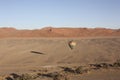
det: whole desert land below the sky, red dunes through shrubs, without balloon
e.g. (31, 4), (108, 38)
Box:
(0, 27), (120, 80)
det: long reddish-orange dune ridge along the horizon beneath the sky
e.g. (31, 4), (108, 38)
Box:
(0, 27), (120, 38)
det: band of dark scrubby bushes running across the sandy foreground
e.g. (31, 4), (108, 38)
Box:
(2, 60), (120, 80)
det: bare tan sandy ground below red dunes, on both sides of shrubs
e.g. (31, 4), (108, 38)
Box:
(0, 37), (120, 80)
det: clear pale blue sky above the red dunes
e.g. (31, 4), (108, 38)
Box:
(0, 0), (120, 29)
